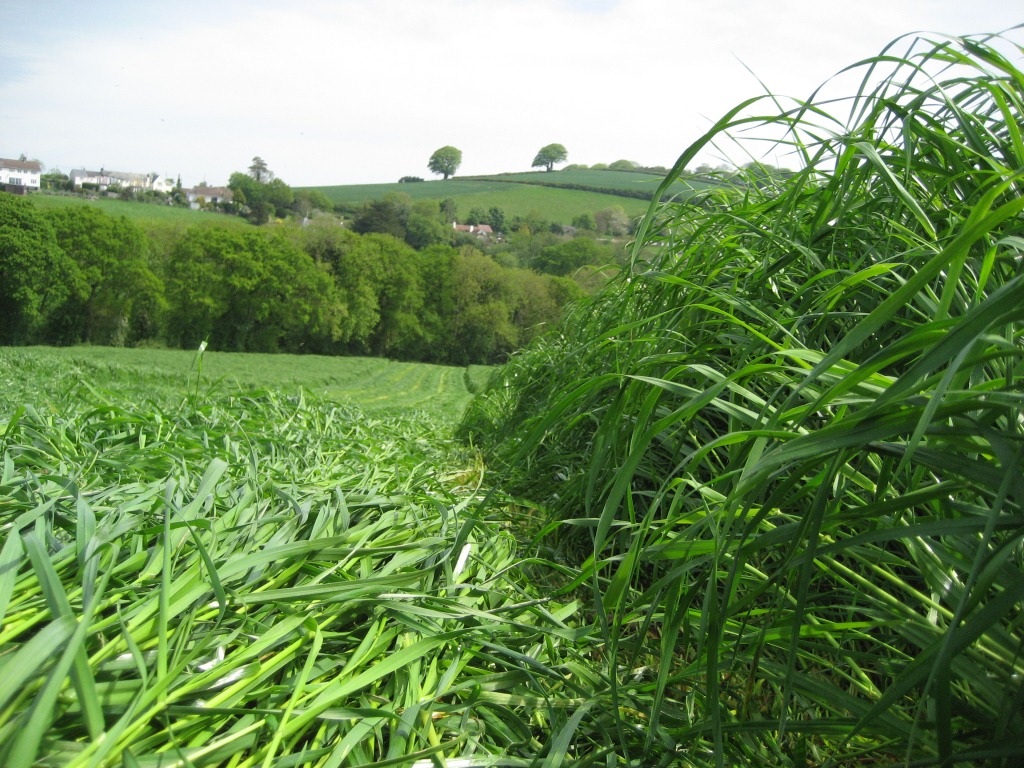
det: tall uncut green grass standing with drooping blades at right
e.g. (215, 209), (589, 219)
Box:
(465, 30), (1024, 766)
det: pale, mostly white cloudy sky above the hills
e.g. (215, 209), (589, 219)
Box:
(0, 0), (1024, 186)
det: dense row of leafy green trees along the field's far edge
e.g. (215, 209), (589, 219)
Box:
(0, 191), (585, 365)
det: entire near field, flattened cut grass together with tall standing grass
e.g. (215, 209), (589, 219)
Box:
(0, 27), (1024, 768)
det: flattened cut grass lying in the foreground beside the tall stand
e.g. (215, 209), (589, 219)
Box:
(0, 370), (587, 768)
